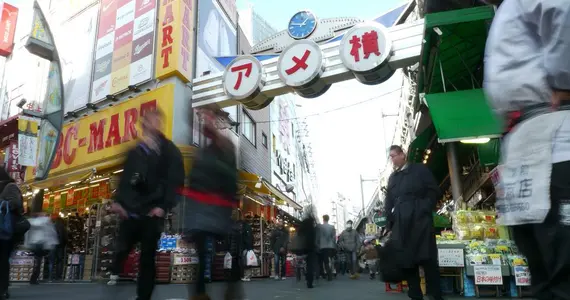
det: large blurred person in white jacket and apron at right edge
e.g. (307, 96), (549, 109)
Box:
(483, 0), (570, 300)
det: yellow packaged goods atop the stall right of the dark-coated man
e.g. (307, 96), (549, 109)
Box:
(453, 210), (499, 240)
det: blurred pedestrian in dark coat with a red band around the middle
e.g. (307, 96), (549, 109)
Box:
(184, 108), (244, 300)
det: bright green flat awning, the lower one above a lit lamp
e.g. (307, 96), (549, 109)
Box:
(425, 89), (502, 143)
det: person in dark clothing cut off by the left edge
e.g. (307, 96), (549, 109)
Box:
(0, 167), (30, 300)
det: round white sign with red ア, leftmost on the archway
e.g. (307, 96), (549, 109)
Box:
(224, 55), (263, 100)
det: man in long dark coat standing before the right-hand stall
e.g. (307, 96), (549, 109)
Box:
(384, 146), (443, 300)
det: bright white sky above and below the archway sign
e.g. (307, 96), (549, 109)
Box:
(237, 0), (406, 214)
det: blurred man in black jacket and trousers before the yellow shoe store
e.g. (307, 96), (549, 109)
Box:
(108, 110), (184, 300)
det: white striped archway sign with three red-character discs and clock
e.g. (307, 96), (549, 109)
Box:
(192, 11), (424, 110)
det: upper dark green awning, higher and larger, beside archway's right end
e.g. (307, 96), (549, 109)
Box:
(416, 6), (495, 108)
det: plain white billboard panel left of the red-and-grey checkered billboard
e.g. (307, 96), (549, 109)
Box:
(54, 5), (101, 113)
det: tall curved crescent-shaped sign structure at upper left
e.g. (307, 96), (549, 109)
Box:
(23, 1), (65, 180)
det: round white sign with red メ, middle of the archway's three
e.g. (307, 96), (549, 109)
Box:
(277, 40), (330, 98)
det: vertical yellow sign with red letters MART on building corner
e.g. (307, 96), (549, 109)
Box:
(156, 0), (194, 82)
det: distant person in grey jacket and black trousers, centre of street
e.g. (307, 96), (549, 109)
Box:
(317, 215), (336, 281)
